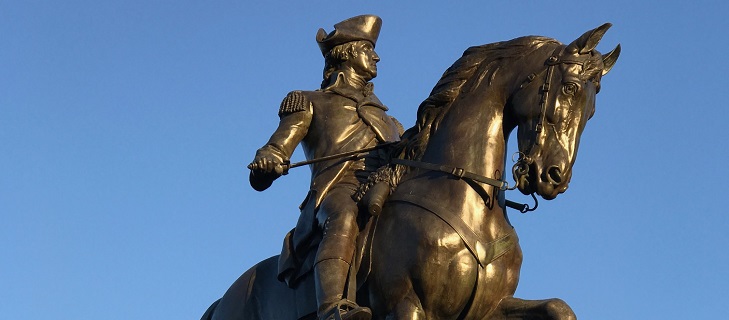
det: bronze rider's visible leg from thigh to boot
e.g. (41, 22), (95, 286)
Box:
(314, 188), (371, 320)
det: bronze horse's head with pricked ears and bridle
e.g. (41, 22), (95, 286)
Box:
(510, 23), (620, 200)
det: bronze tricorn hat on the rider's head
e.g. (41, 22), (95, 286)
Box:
(316, 14), (382, 55)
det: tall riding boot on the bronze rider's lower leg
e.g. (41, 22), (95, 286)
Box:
(314, 259), (372, 320)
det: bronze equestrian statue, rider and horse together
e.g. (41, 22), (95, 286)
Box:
(203, 15), (620, 320)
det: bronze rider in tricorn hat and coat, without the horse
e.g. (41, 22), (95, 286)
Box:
(249, 15), (402, 320)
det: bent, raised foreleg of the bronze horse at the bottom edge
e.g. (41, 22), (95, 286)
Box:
(490, 297), (577, 320)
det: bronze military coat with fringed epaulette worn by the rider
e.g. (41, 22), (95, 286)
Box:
(251, 75), (402, 264)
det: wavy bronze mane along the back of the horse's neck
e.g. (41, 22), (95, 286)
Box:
(398, 36), (561, 160)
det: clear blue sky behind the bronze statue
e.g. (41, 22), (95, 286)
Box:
(0, 0), (729, 320)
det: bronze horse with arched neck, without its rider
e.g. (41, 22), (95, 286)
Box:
(203, 24), (620, 320)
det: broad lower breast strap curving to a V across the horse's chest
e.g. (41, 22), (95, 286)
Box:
(388, 193), (519, 267)
